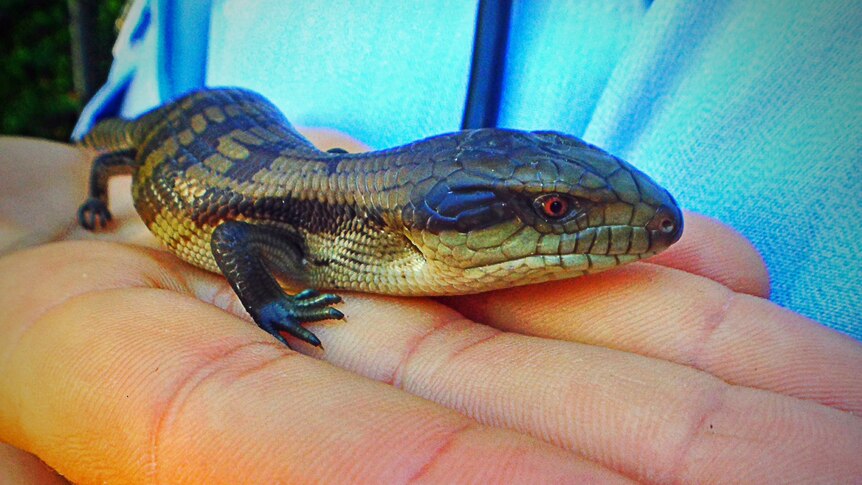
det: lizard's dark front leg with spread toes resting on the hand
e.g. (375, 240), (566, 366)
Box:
(210, 221), (344, 347)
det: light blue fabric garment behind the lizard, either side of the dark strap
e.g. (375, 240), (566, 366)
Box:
(76, 0), (862, 338)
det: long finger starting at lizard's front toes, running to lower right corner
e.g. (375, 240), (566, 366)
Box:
(313, 295), (862, 483)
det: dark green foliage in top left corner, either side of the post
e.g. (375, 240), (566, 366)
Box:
(0, 0), (124, 141)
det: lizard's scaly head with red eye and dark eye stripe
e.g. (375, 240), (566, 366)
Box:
(400, 130), (683, 293)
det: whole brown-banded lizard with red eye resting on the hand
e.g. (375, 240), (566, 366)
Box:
(78, 88), (683, 346)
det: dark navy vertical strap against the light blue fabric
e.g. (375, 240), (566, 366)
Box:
(461, 0), (512, 129)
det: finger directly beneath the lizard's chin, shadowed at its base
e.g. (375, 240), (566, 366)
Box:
(445, 264), (862, 413)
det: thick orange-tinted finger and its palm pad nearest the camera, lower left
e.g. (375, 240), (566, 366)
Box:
(0, 243), (619, 483)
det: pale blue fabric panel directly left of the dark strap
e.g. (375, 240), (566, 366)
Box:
(207, 0), (476, 147)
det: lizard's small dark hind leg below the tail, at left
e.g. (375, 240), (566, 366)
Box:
(78, 150), (135, 231)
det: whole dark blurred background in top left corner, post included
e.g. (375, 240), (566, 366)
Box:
(0, 0), (126, 141)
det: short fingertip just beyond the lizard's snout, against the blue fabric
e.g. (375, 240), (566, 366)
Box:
(648, 211), (769, 298)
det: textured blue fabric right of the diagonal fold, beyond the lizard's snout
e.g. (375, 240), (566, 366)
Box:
(585, 0), (862, 338)
